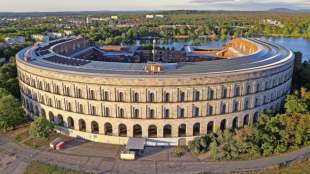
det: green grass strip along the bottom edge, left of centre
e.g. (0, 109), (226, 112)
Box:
(24, 161), (86, 174)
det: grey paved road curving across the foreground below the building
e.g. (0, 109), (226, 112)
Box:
(0, 137), (310, 174)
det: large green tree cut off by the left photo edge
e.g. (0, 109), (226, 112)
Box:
(0, 92), (24, 131)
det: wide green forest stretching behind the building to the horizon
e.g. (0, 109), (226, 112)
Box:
(0, 11), (310, 45)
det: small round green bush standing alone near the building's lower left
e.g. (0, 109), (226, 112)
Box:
(29, 117), (54, 138)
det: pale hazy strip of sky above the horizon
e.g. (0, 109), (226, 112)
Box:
(0, 0), (310, 12)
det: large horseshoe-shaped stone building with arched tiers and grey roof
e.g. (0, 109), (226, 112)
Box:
(16, 38), (294, 145)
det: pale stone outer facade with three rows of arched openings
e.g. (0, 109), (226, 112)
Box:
(17, 54), (293, 145)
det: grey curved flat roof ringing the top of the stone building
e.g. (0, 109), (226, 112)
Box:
(17, 39), (294, 77)
